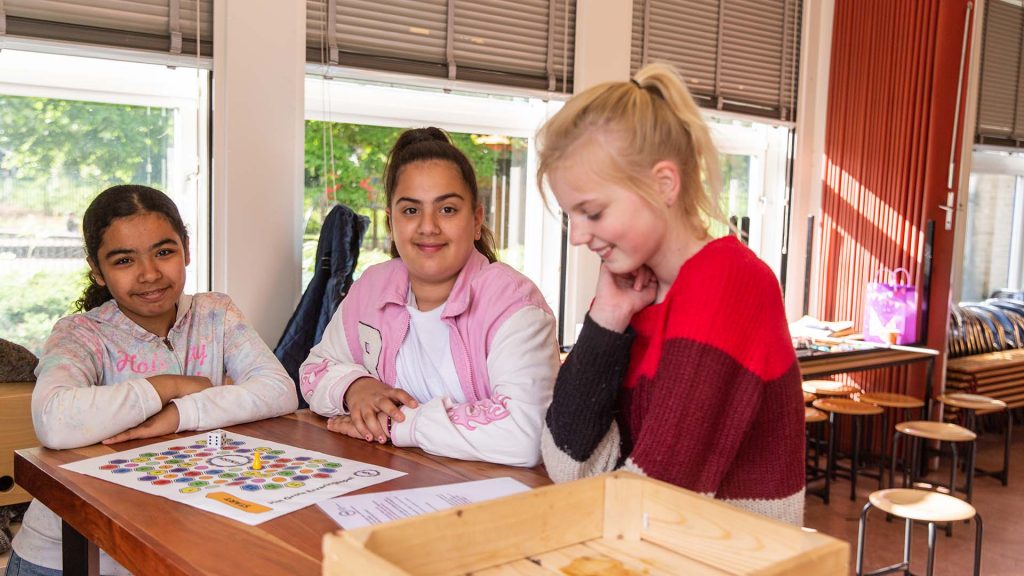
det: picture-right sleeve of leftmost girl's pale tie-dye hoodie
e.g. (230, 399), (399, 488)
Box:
(171, 301), (299, 433)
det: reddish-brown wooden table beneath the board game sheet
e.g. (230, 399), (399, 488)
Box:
(14, 410), (551, 576)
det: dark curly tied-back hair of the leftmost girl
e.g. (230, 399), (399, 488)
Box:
(74, 184), (188, 312)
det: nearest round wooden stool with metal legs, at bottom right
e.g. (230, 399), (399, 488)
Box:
(857, 488), (982, 576)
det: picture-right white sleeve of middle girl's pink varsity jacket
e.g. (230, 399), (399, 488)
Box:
(391, 306), (558, 466)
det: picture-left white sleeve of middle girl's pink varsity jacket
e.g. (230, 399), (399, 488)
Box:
(299, 303), (377, 417)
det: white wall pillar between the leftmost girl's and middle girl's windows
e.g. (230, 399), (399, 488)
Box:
(212, 0), (306, 340)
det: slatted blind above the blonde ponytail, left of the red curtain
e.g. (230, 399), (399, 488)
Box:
(631, 0), (803, 121)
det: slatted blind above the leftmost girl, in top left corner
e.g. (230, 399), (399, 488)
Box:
(0, 0), (213, 54)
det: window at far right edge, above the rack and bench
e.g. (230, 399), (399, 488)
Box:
(959, 149), (1024, 301)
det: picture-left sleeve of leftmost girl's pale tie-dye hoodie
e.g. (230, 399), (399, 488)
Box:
(32, 318), (164, 450)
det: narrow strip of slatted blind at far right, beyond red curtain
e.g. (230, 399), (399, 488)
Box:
(976, 0), (1024, 147)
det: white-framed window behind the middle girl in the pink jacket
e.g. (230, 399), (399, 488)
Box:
(302, 78), (561, 311)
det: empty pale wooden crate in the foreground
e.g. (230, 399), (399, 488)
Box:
(324, 472), (850, 576)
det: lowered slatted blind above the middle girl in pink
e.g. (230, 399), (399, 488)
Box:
(306, 0), (575, 91)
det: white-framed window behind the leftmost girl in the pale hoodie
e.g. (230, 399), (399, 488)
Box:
(0, 49), (209, 354)
